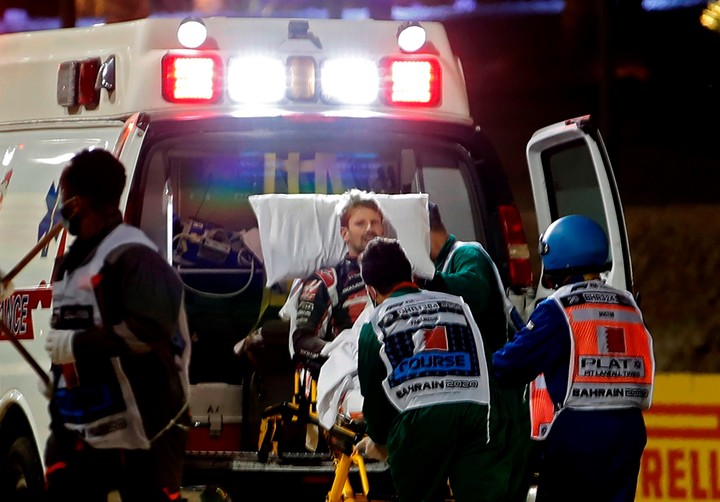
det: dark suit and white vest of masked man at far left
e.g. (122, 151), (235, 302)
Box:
(46, 220), (189, 501)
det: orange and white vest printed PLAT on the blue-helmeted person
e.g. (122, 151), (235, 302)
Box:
(531, 281), (655, 439)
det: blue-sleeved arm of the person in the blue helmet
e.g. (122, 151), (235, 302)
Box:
(492, 300), (570, 384)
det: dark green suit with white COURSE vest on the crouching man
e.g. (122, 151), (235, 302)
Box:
(358, 283), (498, 502)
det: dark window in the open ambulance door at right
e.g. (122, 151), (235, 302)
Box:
(542, 140), (607, 237)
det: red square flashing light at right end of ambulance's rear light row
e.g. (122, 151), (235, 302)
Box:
(380, 58), (442, 106)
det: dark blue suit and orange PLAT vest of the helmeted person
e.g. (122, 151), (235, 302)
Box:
(493, 281), (654, 502)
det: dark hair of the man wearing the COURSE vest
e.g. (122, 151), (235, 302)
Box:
(360, 237), (412, 294)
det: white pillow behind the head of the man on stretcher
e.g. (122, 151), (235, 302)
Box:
(249, 193), (435, 287)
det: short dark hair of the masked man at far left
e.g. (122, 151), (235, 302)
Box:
(60, 148), (126, 209)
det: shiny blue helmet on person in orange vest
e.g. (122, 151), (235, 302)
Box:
(538, 214), (610, 274)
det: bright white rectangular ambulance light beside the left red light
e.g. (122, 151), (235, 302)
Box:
(228, 56), (287, 103)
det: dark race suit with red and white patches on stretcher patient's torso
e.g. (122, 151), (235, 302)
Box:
(292, 256), (369, 370)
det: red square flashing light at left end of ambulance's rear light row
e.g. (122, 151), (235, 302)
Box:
(162, 51), (223, 103)
